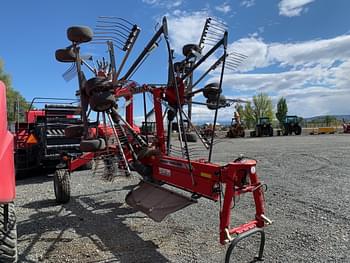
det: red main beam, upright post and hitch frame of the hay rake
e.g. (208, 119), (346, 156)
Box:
(138, 88), (265, 244)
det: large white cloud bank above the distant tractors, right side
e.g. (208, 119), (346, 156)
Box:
(204, 35), (350, 117)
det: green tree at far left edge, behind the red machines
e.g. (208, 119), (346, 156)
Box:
(0, 59), (29, 121)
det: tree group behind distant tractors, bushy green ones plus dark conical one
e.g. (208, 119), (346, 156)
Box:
(237, 93), (288, 128)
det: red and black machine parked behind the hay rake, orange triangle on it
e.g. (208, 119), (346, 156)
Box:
(15, 98), (93, 175)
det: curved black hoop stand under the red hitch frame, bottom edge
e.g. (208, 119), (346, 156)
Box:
(225, 228), (265, 263)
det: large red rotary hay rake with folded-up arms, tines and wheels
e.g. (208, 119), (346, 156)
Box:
(54, 17), (271, 262)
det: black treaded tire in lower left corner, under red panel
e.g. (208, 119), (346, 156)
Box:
(0, 203), (18, 263)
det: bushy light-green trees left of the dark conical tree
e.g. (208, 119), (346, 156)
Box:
(242, 93), (273, 128)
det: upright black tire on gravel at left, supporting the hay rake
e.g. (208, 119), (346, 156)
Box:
(53, 169), (70, 204)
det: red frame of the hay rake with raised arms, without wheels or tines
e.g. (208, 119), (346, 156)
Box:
(55, 16), (272, 262)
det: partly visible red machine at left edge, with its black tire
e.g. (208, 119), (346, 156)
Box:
(0, 81), (17, 263)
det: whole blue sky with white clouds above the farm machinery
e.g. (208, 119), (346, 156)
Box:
(0, 0), (350, 121)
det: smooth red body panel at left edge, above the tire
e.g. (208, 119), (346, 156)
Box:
(0, 81), (16, 203)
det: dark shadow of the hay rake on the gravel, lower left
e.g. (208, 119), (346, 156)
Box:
(17, 193), (169, 263)
